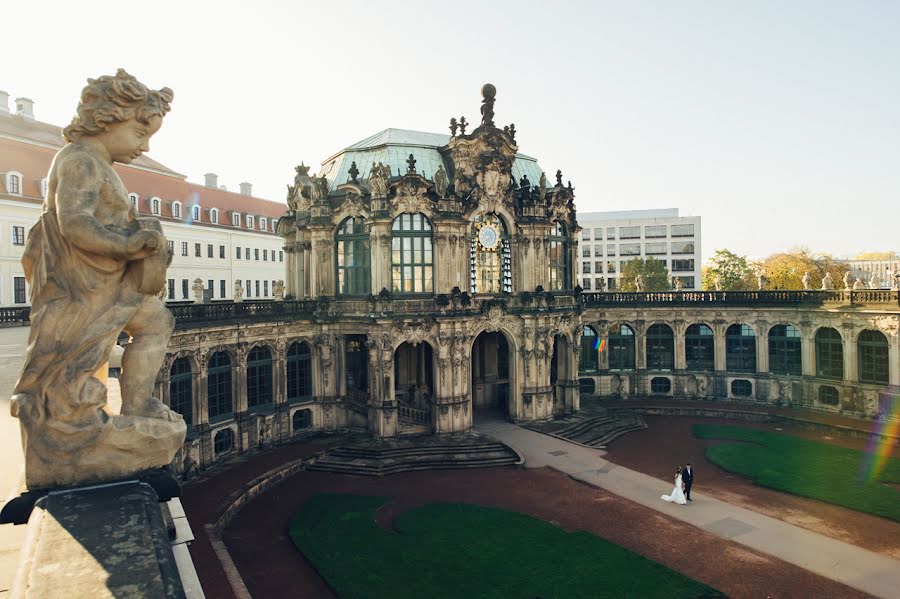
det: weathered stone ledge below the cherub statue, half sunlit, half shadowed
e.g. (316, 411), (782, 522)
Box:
(10, 481), (185, 599)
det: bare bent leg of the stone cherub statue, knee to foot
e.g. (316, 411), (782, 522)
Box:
(119, 296), (175, 418)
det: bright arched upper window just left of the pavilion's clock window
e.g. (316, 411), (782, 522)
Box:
(391, 213), (434, 293)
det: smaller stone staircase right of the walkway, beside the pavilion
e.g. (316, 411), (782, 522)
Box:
(527, 407), (647, 448)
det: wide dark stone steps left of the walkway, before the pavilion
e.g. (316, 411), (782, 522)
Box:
(308, 434), (522, 476)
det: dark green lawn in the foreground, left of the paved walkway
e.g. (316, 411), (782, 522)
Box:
(290, 494), (723, 599)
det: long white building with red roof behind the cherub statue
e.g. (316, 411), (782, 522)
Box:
(0, 92), (287, 306)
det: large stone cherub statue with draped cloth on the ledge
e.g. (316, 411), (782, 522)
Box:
(11, 69), (187, 490)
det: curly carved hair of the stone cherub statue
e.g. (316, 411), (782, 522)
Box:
(63, 69), (175, 143)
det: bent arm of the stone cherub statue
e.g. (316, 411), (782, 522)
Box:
(56, 156), (155, 260)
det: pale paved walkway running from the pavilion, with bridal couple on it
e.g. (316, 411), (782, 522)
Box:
(475, 420), (900, 599)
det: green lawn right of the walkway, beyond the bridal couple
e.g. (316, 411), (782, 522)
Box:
(694, 424), (900, 521)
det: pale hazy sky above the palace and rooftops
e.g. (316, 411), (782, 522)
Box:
(0, 0), (900, 258)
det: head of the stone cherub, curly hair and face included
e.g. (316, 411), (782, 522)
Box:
(63, 69), (175, 164)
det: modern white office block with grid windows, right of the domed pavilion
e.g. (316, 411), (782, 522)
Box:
(578, 208), (701, 292)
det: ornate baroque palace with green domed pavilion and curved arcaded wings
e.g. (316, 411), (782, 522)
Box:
(157, 85), (900, 472)
